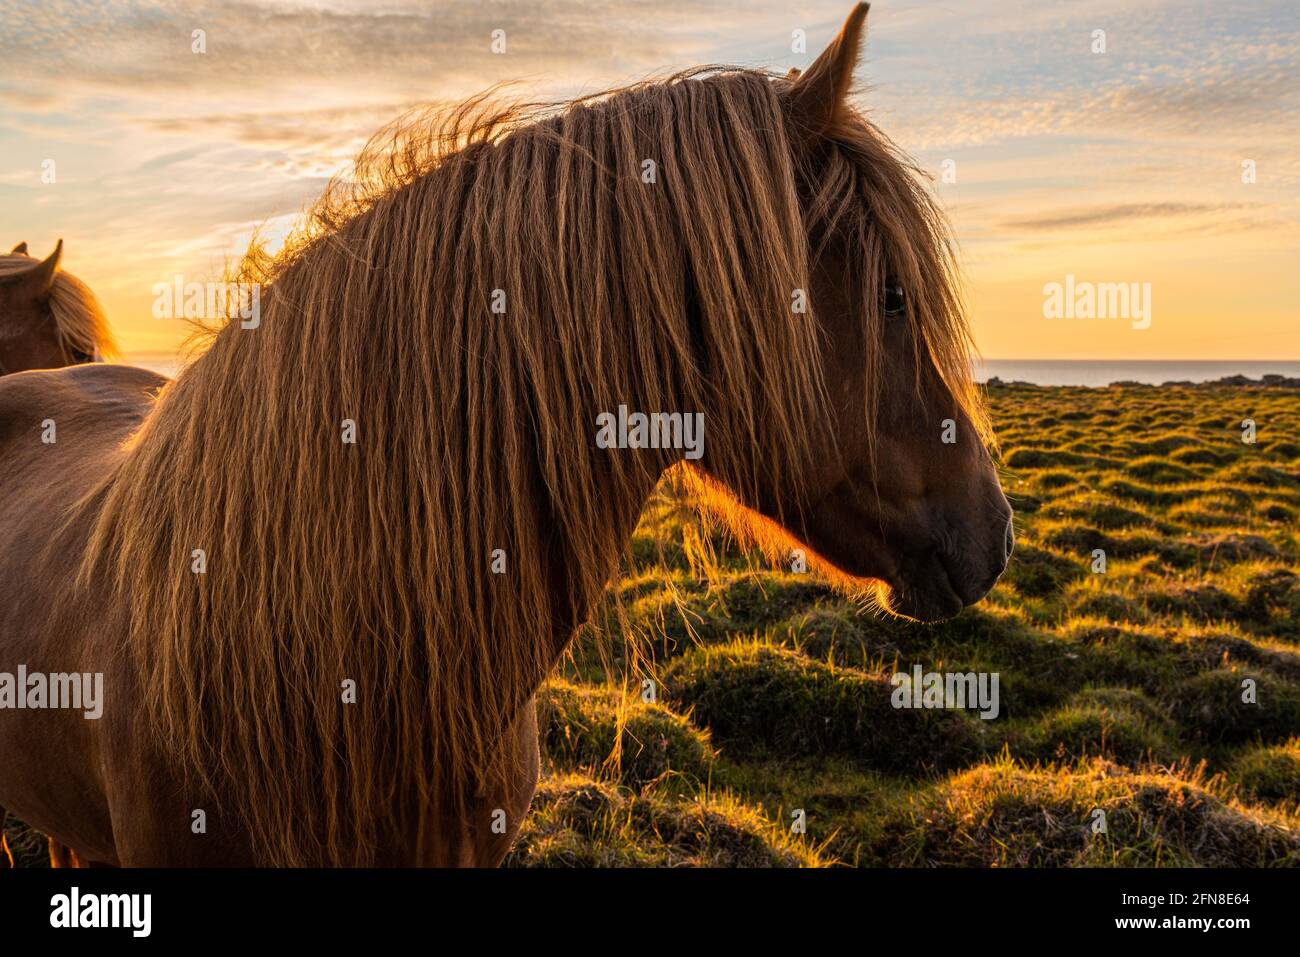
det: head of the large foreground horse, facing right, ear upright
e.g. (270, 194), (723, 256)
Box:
(705, 4), (1013, 620)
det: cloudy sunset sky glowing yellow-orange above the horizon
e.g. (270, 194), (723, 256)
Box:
(0, 0), (1300, 360)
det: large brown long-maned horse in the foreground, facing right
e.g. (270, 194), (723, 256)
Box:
(0, 5), (1010, 865)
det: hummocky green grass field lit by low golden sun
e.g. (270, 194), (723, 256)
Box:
(10, 386), (1300, 866)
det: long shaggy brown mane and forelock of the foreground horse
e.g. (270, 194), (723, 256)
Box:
(83, 68), (978, 865)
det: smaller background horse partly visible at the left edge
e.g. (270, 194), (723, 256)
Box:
(0, 239), (116, 376)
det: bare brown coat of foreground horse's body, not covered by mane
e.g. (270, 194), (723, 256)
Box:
(0, 365), (548, 866)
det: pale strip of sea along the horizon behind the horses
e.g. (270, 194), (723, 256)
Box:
(125, 352), (1300, 386)
